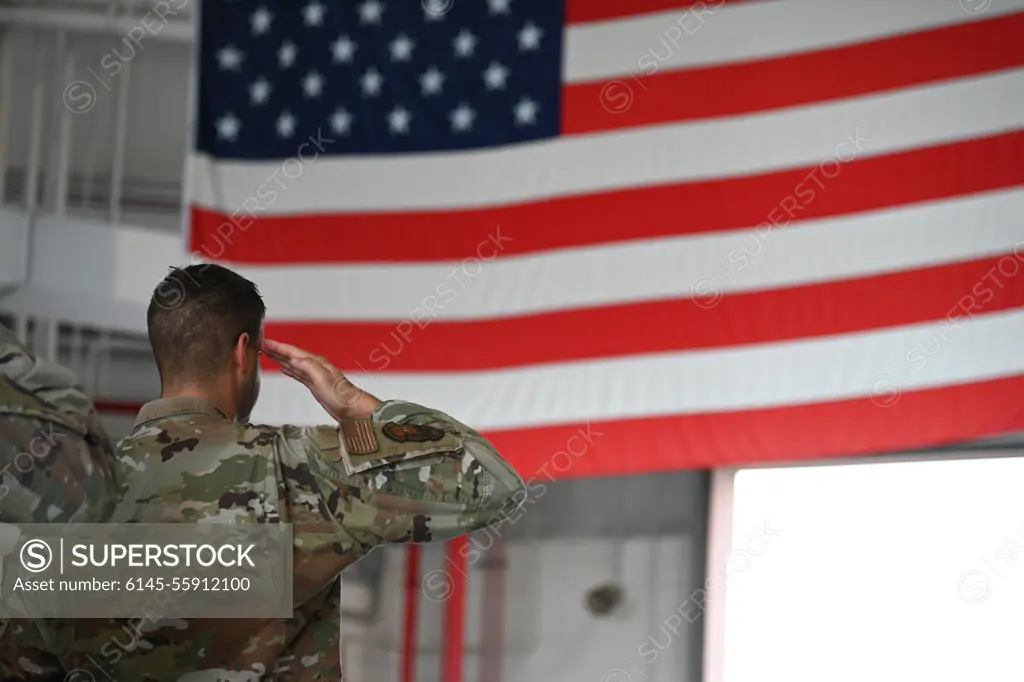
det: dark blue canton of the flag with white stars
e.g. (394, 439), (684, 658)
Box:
(197, 0), (564, 160)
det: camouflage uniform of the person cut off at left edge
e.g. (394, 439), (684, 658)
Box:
(0, 325), (120, 680)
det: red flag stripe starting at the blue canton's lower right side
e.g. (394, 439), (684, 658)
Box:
(562, 12), (1024, 134)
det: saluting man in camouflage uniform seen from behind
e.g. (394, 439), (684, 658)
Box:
(37, 264), (525, 682)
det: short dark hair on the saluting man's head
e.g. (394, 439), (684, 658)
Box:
(145, 263), (266, 385)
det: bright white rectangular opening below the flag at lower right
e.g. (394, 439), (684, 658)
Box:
(705, 452), (1024, 682)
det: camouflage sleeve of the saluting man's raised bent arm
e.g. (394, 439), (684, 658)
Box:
(274, 400), (525, 549)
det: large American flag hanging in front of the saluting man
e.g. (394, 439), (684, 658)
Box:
(189, 0), (1024, 477)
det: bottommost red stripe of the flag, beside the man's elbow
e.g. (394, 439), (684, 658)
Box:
(484, 375), (1024, 477)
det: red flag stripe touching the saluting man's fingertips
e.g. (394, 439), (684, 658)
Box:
(265, 254), (1024, 372)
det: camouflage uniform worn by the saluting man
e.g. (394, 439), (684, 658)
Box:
(34, 398), (525, 682)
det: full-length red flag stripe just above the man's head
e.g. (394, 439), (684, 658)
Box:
(191, 130), (1024, 265)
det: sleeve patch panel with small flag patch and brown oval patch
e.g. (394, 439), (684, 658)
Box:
(331, 419), (463, 474)
